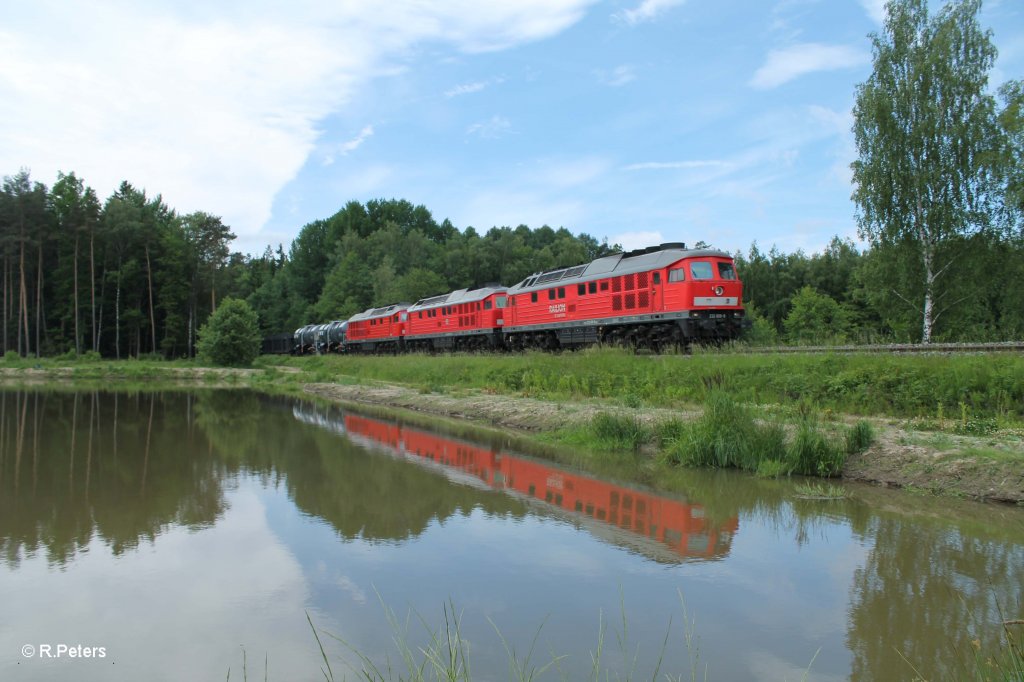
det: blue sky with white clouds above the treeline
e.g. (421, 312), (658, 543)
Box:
(0, 0), (1024, 253)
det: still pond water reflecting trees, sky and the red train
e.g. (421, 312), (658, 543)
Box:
(0, 391), (1024, 680)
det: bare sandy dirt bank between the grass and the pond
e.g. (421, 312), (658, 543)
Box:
(303, 384), (1024, 504)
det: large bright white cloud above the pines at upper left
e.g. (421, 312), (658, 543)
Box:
(0, 0), (594, 249)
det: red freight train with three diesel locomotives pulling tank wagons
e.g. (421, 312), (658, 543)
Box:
(278, 243), (748, 354)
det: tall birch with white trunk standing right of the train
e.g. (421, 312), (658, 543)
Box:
(852, 0), (1000, 343)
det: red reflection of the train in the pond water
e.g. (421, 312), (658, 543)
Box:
(293, 403), (738, 562)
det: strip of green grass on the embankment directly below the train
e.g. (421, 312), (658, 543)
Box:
(266, 348), (1024, 421)
